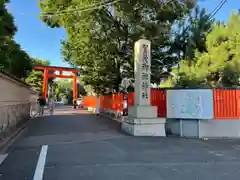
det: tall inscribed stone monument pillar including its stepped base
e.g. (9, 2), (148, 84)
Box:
(122, 39), (166, 136)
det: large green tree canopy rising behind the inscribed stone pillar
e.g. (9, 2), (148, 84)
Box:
(40, 0), (193, 93)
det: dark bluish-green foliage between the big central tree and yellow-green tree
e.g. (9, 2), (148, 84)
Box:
(170, 6), (214, 63)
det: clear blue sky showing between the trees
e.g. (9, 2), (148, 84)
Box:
(8, 0), (237, 67)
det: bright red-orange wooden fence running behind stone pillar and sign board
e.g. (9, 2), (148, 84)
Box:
(84, 89), (240, 120)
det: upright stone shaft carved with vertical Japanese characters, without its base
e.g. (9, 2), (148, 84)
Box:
(134, 39), (151, 105)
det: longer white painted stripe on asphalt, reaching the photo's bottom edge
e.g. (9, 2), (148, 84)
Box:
(33, 145), (48, 180)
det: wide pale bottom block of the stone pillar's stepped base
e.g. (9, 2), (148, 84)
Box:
(122, 118), (166, 137)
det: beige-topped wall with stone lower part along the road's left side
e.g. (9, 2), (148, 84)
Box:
(0, 71), (34, 138)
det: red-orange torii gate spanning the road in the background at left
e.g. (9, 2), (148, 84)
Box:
(35, 65), (79, 100)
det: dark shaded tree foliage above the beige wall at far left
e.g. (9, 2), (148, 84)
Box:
(0, 0), (32, 78)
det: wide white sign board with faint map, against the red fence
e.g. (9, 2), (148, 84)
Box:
(167, 89), (214, 119)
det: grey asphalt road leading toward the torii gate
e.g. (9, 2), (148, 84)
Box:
(0, 107), (240, 180)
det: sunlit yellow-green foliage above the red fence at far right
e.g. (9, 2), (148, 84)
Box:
(177, 13), (240, 87)
